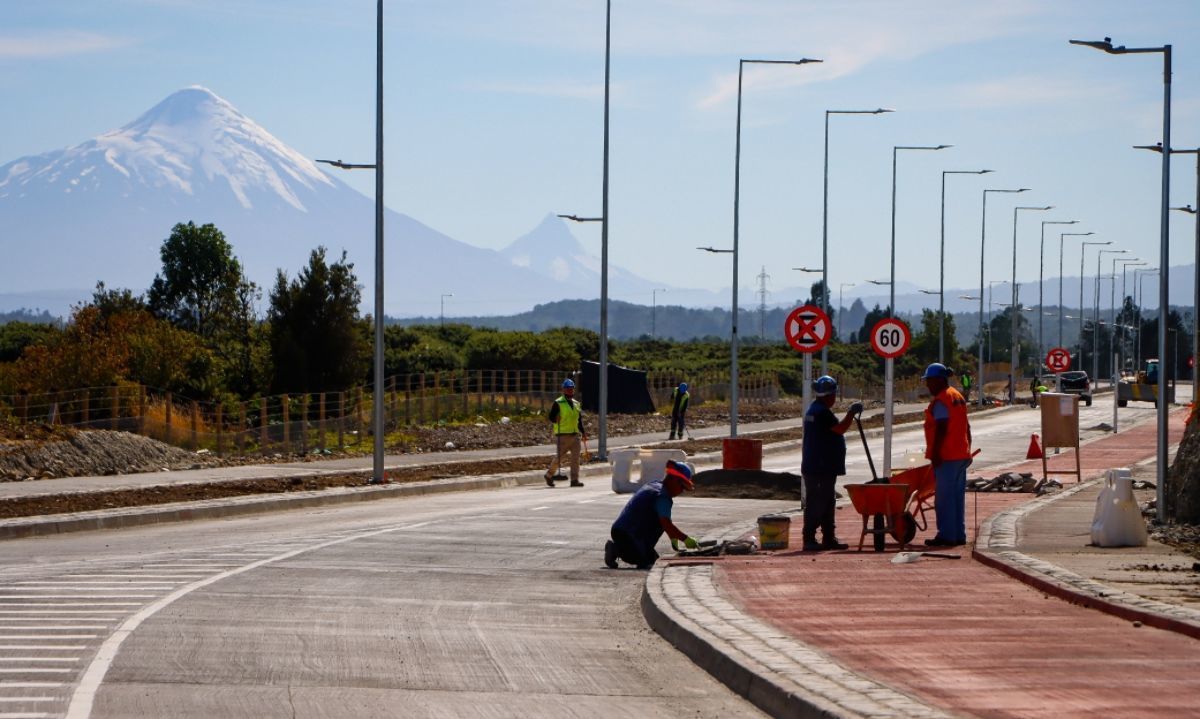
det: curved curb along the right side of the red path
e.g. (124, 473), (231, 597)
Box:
(971, 479), (1200, 639)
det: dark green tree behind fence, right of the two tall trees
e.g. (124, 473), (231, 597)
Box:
(268, 247), (371, 393)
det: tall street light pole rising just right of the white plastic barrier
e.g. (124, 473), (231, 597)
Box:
(1070, 37), (1171, 522)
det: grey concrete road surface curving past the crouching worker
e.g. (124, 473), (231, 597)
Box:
(0, 388), (1180, 719)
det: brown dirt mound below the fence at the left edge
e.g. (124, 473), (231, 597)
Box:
(0, 431), (221, 481)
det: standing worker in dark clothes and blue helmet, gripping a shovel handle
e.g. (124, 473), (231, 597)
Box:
(800, 375), (863, 552)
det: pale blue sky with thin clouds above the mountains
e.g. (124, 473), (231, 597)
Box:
(0, 0), (1200, 304)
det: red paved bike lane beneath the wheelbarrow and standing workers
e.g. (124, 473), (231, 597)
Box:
(715, 413), (1200, 718)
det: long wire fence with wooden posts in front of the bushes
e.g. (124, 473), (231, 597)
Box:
(0, 370), (780, 456)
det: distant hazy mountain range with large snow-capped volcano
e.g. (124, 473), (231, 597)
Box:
(0, 86), (1192, 317)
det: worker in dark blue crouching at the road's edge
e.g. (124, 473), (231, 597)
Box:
(604, 460), (698, 569)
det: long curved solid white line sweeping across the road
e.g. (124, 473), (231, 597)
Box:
(66, 522), (432, 719)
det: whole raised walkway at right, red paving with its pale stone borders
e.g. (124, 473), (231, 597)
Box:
(643, 412), (1200, 718)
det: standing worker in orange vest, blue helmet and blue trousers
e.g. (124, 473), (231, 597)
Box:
(922, 363), (971, 546)
